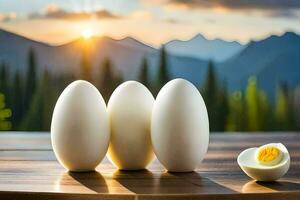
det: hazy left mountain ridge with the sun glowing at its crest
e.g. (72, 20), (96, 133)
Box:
(0, 30), (207, 85)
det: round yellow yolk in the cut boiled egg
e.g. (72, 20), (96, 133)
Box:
(256, 146), (281, 165)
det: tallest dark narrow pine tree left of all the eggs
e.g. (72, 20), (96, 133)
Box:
(24, 49), (37, 112)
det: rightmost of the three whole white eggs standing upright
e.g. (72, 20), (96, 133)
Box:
(151, 79), (209, 172)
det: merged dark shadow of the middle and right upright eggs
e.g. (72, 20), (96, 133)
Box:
(113, 170), (236, 195)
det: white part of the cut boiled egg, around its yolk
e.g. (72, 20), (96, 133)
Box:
(237, 145), (290, 181)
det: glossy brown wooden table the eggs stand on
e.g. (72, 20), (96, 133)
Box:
(0, 132), (300, 200)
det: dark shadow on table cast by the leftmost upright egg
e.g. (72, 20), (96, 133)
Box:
(66, 171), (108, 193)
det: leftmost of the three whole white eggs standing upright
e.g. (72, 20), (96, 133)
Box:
(51, 80), (110, 171)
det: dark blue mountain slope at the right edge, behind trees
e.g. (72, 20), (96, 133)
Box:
(218, 32), (300, 99)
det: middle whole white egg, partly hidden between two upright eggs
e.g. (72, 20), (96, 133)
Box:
(107, 81), (154, 170)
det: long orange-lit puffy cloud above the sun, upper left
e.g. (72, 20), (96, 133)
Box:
(28, 4), (121, 20)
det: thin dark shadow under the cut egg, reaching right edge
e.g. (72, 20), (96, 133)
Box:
(256, 181), (300, 191)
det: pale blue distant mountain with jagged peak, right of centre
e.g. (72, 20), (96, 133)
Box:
(166, 34), (243, 62)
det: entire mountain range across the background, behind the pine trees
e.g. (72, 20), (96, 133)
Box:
(0, 27), (300, 100)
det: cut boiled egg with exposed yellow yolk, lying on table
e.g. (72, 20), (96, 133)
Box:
(237, 143), (290, 181)
